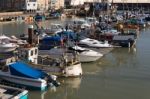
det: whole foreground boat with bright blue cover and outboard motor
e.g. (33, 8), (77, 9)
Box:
(0, 58), (59, 90)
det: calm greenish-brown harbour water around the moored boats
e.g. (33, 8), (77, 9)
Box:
(0, 21), (150, 99)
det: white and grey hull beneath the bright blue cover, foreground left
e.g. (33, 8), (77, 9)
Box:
(0, 71), (47, 90)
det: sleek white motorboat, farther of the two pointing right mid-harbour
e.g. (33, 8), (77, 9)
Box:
(79, 38), (113, 48)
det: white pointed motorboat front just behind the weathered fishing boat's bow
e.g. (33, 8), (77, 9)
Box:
(69, 46), (103, 62)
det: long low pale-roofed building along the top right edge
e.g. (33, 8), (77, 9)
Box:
(66, 0), (150, 10)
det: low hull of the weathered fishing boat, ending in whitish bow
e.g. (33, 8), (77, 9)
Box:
(32, 62), (82, 77)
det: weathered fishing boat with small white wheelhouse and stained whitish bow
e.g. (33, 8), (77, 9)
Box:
(18, 46), (82, 77)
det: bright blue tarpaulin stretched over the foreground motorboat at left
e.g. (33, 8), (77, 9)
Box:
(9, 62), (47, 79)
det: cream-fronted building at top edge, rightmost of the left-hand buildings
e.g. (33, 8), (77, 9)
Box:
(49, 0), (65, 10)
